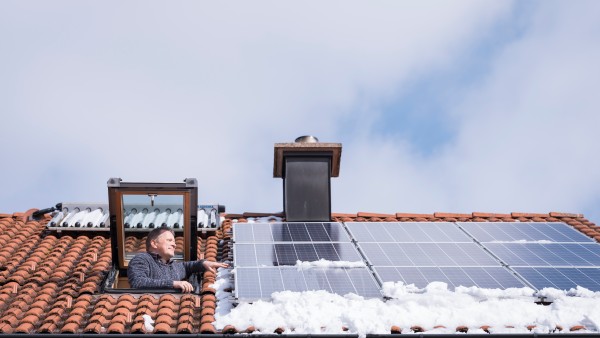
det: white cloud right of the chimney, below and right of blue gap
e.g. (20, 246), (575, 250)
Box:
(338, 2), (600, 222)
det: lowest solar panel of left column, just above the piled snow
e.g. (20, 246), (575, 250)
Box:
(235, 267), (381, 301)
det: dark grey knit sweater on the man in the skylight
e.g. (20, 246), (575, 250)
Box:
(127, 252), (204, 289)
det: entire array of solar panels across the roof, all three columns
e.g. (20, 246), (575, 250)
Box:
(234, 222), (600, 297)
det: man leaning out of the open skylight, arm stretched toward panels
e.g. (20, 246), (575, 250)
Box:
(127, 228), (228, 292)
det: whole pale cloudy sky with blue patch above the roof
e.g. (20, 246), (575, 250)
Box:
(0, 0), (600, 224)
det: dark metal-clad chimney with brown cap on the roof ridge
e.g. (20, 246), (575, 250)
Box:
(273, 136), (342, 222)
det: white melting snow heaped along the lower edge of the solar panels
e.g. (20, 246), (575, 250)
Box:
(214, 272), (600, 336)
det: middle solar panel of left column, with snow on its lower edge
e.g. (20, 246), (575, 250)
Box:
(233, 243), (362, 267)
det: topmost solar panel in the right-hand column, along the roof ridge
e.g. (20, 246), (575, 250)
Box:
(458, 222), (594, 243)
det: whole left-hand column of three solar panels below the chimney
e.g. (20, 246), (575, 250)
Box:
(233, 222), (382, 301)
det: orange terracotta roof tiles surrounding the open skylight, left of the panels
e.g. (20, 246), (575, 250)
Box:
(0, 214), (230, 333)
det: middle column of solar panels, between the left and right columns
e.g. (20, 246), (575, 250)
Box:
(344, 222), (527, 288)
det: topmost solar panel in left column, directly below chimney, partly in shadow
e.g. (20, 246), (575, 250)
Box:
(233, 222), (350, 243)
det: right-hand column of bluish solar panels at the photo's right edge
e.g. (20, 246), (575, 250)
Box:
(457, 222), (600, 291)
